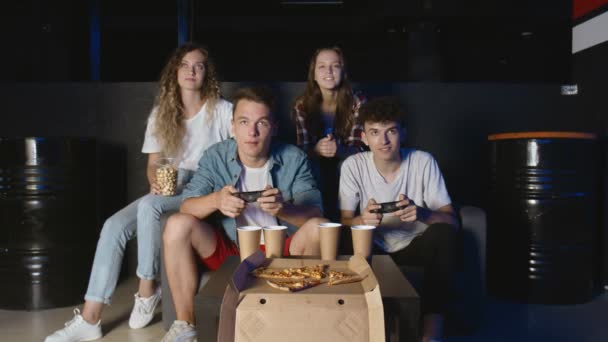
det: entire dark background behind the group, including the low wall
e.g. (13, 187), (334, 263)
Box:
(0, 0), (608, 282)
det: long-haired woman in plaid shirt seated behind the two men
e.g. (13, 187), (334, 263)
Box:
(292, 47), (365, 220)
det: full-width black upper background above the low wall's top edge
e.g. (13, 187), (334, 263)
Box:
(0, 0), (572, 83)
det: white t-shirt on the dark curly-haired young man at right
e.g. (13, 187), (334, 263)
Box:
(340, 149), (451, 253)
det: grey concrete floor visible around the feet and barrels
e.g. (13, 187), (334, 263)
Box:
(0, 277), (608, 342)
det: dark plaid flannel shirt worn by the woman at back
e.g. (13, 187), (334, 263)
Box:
(292, 93), (367, 151)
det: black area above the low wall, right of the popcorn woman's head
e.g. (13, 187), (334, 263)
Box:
(196, 0), (572, 83)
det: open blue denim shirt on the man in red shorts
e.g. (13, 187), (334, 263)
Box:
(182, 138), (322, 243)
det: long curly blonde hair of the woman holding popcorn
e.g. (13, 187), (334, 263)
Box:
(154, 43), (220, 156)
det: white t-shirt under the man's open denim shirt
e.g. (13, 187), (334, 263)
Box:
(236, 161), (278, 245)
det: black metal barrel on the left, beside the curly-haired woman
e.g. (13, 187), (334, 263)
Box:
(0, 138), (98, 310)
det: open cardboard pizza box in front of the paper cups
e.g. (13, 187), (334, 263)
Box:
(218, 252), (385, 342)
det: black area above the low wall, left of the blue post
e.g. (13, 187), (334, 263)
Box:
(0, 0), (89, 82)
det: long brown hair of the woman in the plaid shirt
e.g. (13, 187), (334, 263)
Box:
(294, 46), (355, 139)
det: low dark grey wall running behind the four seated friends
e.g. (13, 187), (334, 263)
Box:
(0, 82), (592, 207)
